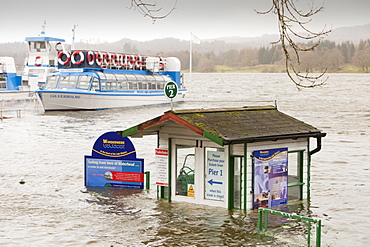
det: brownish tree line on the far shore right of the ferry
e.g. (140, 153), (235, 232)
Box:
(159, 39), (370, 73)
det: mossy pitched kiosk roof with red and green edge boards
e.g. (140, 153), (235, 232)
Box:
(122, 106), (326, 146)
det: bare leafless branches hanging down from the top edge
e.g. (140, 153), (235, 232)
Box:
(131, 0), (331, 88)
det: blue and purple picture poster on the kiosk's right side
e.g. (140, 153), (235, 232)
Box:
(253, 148), (288, 209)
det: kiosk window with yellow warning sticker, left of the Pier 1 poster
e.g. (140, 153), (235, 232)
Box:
(176, 145), (195, 197)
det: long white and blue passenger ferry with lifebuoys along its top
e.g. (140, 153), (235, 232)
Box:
(36, 50), (186, 111)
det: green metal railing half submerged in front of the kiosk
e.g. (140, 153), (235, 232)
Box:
(258, 208), (321, 247)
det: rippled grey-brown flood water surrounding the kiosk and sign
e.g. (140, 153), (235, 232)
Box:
(0, 74), (370, 247)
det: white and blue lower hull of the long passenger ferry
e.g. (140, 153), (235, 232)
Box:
(37, 91), (185, 111)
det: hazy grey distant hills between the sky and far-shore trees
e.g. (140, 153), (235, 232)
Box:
(0, 24), (370, 66)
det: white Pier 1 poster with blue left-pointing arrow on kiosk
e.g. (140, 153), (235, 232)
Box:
(205, 151), (225, 201)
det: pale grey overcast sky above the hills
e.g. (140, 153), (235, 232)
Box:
(0, 0), (370, 43)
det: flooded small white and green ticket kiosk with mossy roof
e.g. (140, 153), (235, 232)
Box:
(119, 106), (326, 210)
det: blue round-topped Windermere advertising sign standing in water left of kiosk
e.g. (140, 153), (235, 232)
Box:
(85, 132), (144, 189)
